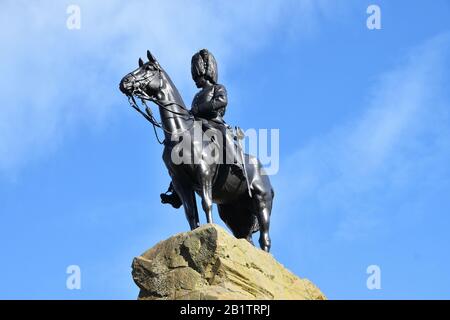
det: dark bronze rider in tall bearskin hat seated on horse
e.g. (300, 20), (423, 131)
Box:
(161, 49), (234, 208)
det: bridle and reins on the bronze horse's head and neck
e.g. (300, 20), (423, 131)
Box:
(127, 68), (194, 144)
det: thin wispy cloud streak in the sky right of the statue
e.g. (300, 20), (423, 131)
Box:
(278, 34), (450, 239)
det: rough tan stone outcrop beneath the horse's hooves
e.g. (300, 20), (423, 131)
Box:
(132, 224), (326, 300)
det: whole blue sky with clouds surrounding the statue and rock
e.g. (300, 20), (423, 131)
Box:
(0, 0), (450, 299)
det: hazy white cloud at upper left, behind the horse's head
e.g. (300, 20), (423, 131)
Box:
(0, 0), (338, 173)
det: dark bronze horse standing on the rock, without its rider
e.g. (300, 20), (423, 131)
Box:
(119, 51), (274, 252)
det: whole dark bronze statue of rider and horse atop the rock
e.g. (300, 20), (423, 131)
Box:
(119, 49), (274, 251)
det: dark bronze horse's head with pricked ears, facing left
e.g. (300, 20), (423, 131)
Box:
(119, 50), (163, 100)
